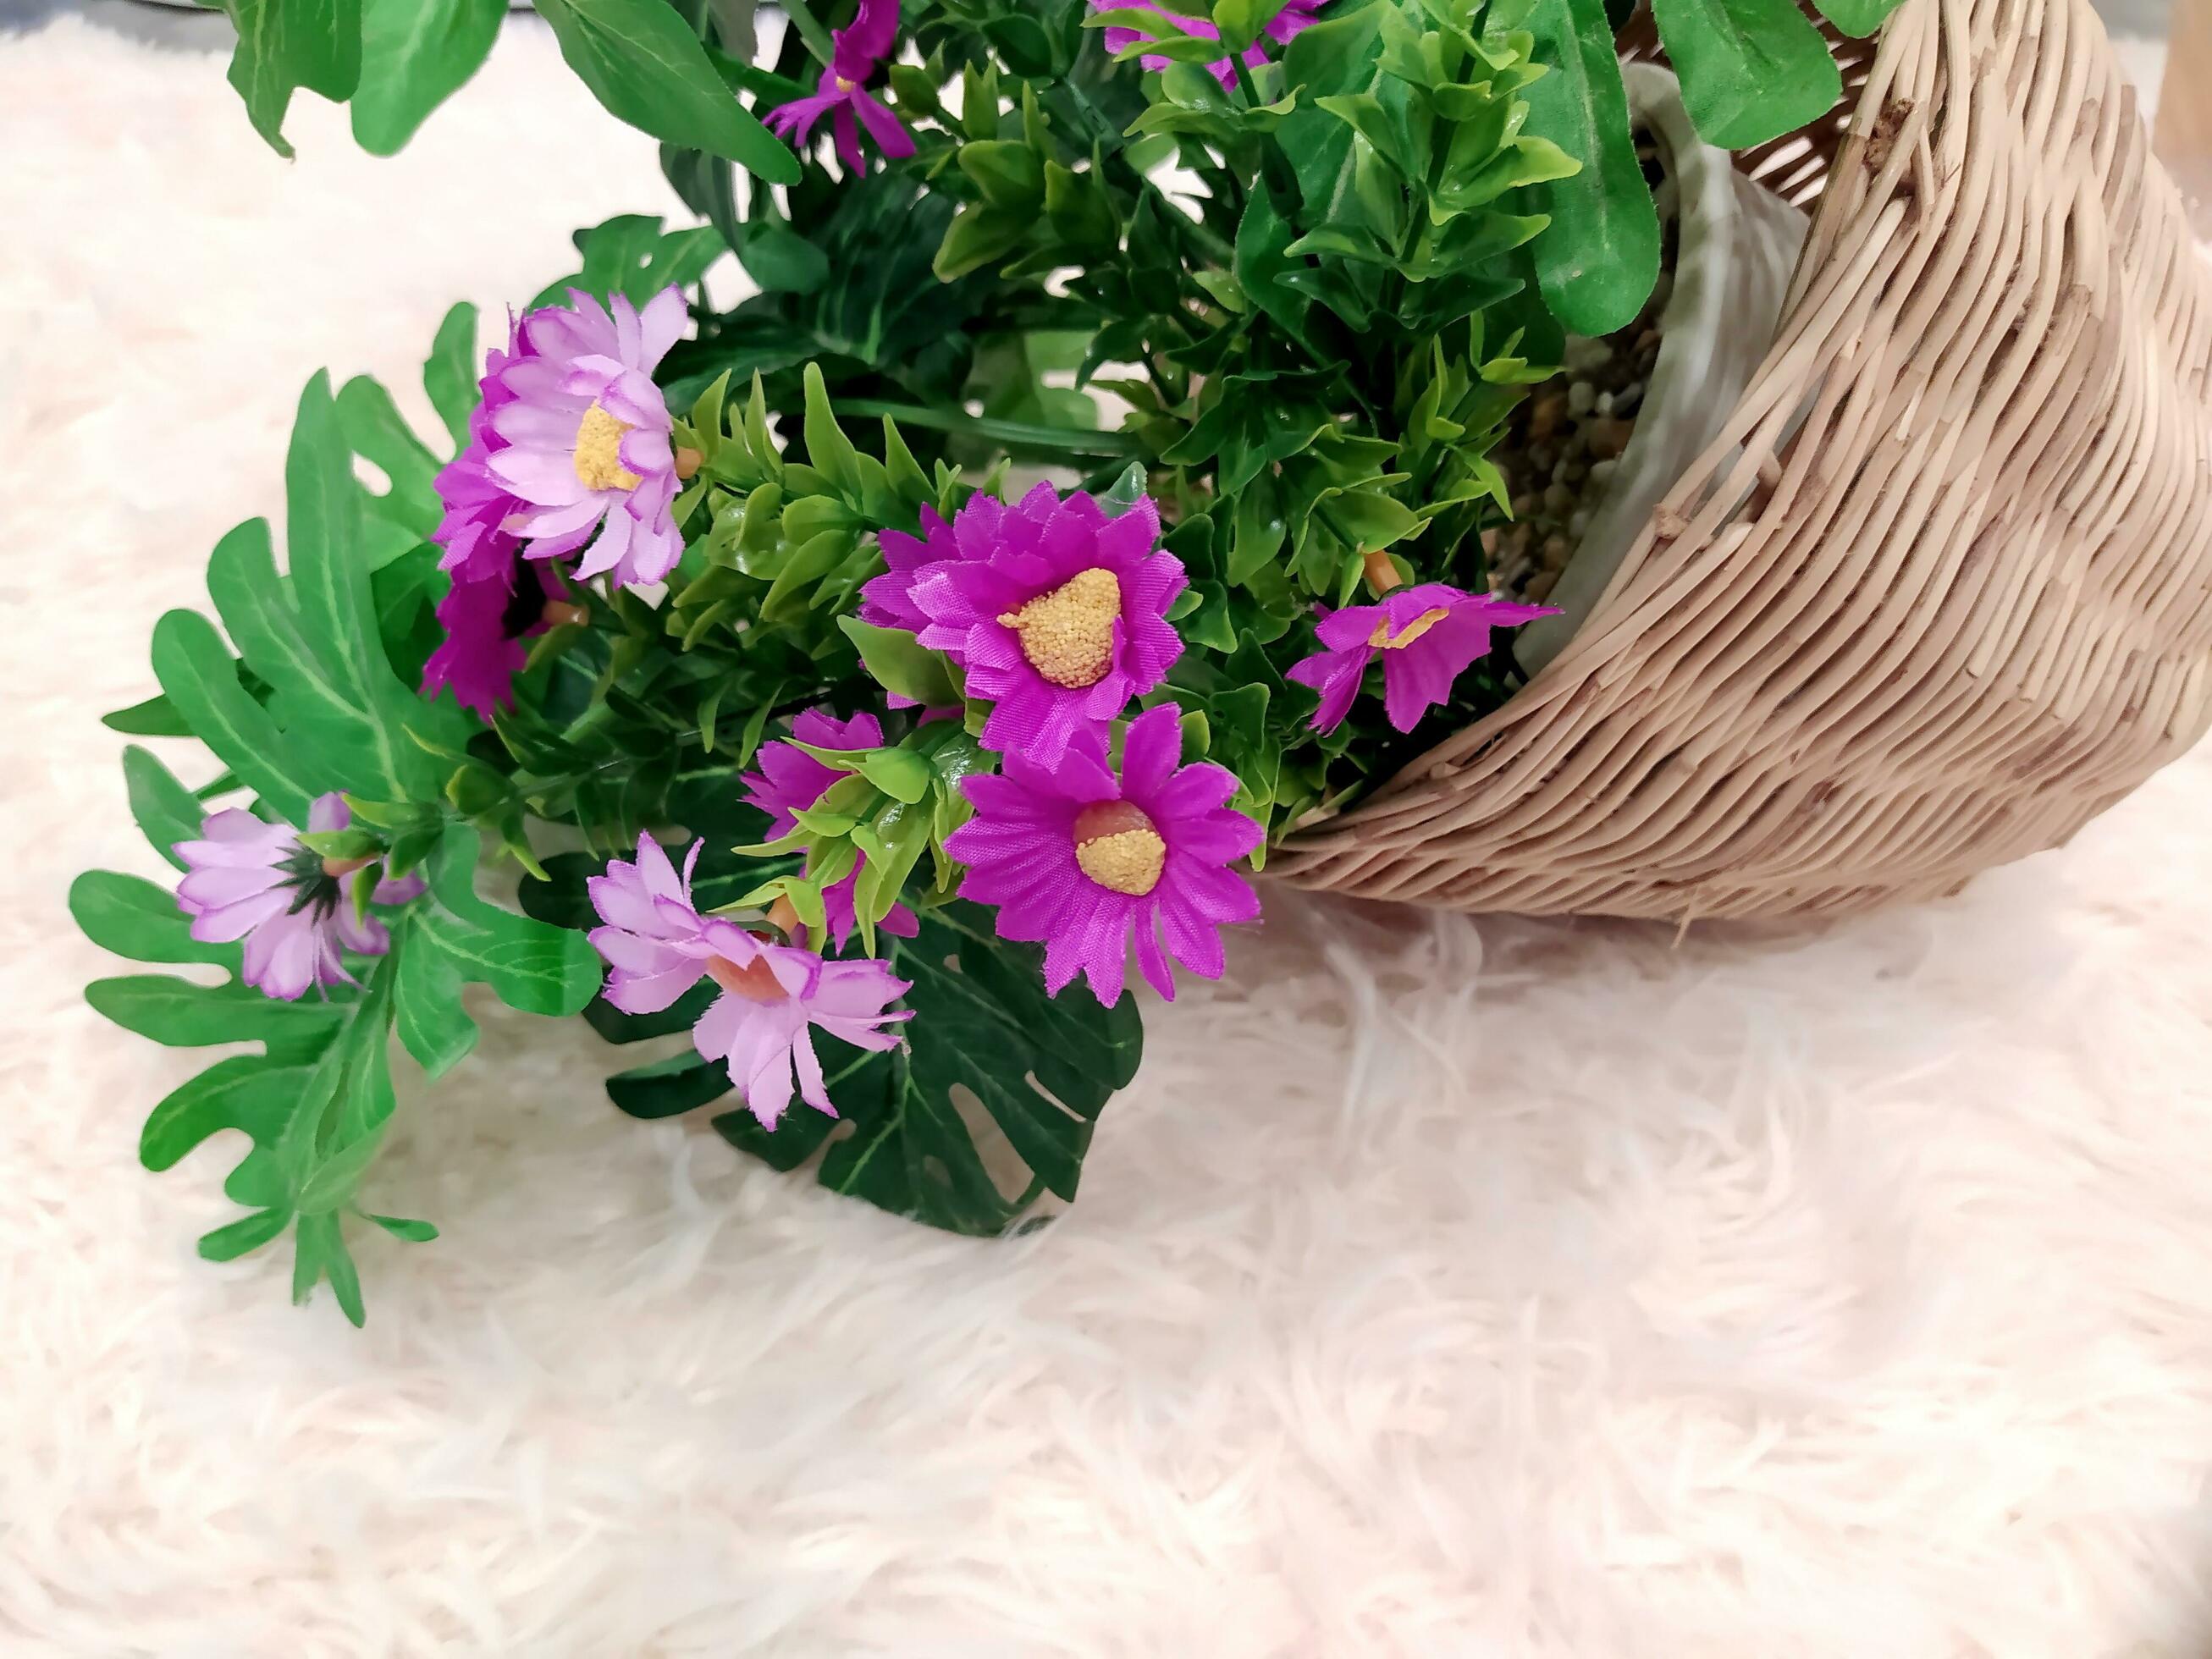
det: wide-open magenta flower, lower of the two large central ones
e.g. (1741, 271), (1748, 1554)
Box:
(945, 703), (1263, 1009)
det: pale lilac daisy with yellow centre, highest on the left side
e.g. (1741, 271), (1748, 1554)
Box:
(484, 285), (688, 587)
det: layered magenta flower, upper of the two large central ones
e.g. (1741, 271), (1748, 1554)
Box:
(860, 484), (1186, 765)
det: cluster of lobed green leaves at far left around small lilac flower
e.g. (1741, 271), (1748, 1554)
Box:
(71, 373), (599, 1323)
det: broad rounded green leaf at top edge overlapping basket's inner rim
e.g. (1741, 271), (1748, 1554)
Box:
(1652, 0), (1843, 151)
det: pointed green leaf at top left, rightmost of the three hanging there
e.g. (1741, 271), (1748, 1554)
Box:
(538, 0), (798, 184)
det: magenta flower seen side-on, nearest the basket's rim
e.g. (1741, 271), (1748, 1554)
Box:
(1289, 581), (1559, 732)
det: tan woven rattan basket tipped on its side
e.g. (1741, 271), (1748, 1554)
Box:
(1270, 0), (2212, 920)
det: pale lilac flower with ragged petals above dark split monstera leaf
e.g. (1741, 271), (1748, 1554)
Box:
(586, 836), (913, 1128)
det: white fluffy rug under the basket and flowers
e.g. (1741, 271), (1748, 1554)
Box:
(0, 20), (2212, 1659)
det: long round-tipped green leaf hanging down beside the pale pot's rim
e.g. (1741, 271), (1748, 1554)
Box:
(1524, 0), (1659, 336)
